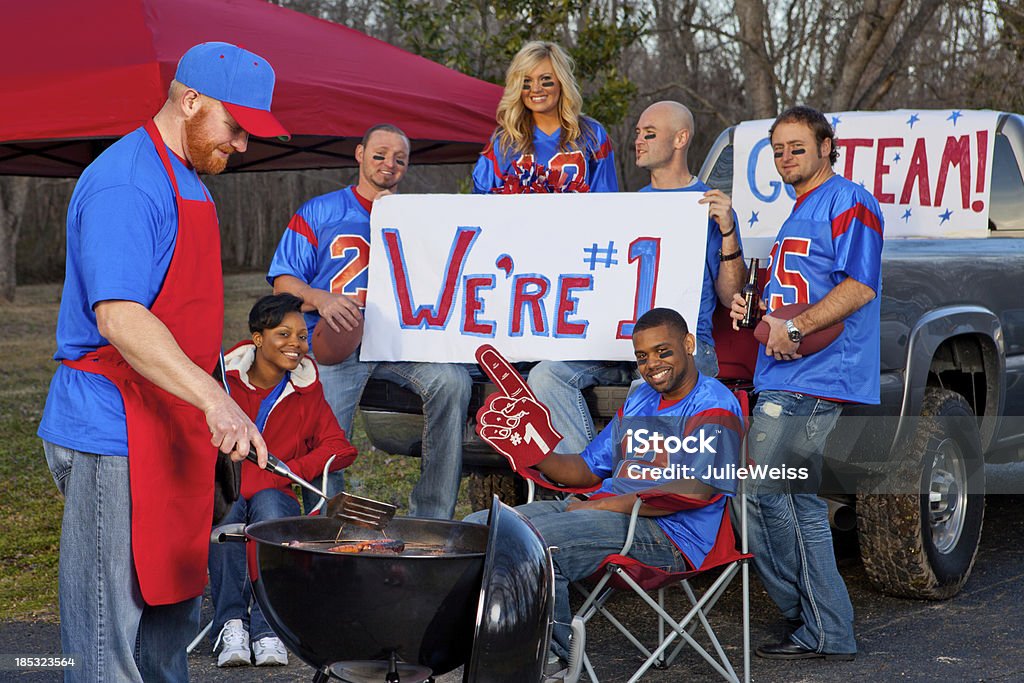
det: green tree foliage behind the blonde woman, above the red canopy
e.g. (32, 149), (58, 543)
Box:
(382, 0), (648, 125)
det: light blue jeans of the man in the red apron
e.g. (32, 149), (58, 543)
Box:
(43, 440), (200, 683)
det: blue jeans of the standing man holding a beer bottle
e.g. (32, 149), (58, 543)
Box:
(746, 391), (857, 653)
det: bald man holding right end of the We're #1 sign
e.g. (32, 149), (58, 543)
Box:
(528, 100), (746, 453)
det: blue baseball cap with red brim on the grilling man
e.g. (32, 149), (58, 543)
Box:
(174, 43), (290, 139)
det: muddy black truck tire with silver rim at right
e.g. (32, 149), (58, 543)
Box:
(857, 387), (985, 600)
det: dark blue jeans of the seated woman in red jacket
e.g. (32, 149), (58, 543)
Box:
(210, 488), (299, 642)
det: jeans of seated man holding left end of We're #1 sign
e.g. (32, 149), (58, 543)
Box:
(317, 353), (472, 519)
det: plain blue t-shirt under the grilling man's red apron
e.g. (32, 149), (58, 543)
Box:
(38, 128), (210, 456)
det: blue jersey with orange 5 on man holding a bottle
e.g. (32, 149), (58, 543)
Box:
(754, 175), (884, 403)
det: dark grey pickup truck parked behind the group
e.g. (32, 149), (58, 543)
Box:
(361, 109), (1024, 599)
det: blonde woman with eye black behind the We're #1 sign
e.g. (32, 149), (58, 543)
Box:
(473, 41), (618, 195)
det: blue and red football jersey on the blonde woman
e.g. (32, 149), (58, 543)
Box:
(473, 117), (618, 195)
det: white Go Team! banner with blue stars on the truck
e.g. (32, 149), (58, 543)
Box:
(732, 110), (998, 239)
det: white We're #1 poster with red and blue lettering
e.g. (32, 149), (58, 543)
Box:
(359, 193), (708, 362)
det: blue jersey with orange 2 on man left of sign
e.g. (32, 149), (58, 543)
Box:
(266, 185), (372, 334)
